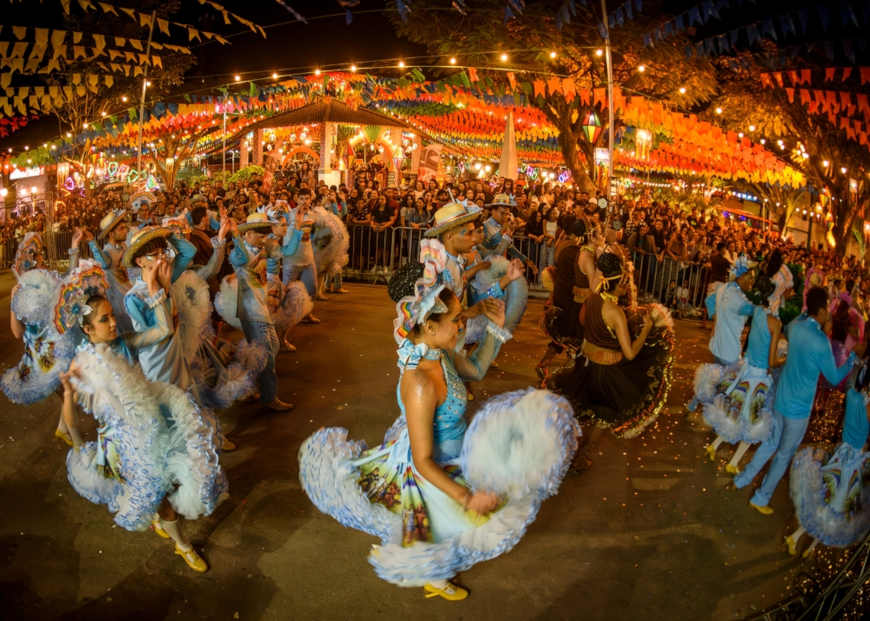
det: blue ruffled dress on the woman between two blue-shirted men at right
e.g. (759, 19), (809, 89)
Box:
(698, 306), (782, 444)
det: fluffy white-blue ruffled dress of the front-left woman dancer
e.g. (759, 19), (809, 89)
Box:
(66, 339), (227, 530)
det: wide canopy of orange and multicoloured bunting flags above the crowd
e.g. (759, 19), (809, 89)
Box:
(5, 71), (804, 187)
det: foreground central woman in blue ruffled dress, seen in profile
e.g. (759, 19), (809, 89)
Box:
(299, 279), (579, 600)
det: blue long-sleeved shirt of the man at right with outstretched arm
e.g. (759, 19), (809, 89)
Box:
(773, 315), (855, 418)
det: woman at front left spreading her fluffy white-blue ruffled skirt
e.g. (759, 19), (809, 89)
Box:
(62, 290), (227, 572)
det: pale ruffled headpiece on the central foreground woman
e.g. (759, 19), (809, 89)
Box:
(393, 239), (447, 345)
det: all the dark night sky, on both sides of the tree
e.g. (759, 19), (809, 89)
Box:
(0, 0), (870, 151)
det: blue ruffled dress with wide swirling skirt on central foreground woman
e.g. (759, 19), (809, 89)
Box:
(299, 341), (580, 586)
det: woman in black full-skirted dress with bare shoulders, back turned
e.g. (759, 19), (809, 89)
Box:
(548, 252), (674, 438)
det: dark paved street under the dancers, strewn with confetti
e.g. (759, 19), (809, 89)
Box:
(0, 275), (800, 621)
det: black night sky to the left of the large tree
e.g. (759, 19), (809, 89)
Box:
(0, 0), (424, 152)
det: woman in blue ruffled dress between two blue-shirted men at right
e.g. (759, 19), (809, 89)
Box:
(704, 265), (788, 474)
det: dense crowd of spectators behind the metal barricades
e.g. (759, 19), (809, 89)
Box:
(0, 163), (870, 314)
